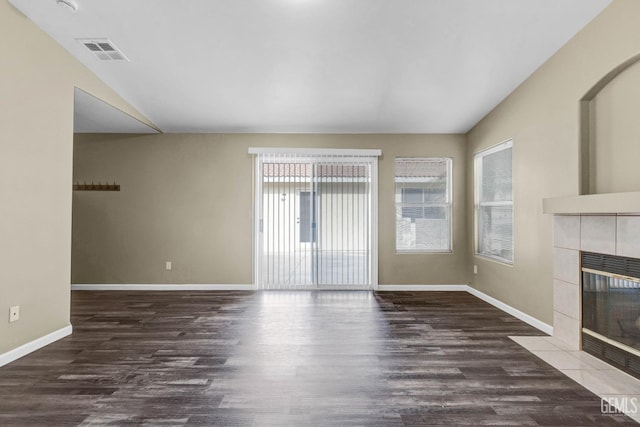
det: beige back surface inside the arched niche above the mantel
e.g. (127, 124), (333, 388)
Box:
(590, 62), (640, 193)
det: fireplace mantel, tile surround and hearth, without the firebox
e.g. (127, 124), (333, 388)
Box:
(536, 196), (640, 423)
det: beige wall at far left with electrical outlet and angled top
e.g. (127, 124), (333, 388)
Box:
(0, 0), (155, 355)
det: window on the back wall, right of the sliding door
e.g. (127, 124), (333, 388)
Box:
(395, 157), (451, 252)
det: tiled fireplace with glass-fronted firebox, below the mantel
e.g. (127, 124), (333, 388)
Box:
(553, 216), (640, 376)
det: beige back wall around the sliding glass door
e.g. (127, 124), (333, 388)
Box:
(72, 134), (469, 284)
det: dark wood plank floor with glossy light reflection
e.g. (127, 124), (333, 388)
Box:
(0, 292), (635, 426)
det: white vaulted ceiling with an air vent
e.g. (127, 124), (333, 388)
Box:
(10, 0), (610, 133)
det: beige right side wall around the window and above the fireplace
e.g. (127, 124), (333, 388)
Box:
(467, 0), (640, 324)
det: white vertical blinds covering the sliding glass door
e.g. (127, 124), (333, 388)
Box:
(250, 152), (377, 289)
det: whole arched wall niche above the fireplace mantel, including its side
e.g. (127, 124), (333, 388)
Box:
(580, 54), (640, 195)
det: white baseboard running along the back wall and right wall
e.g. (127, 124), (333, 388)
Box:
(70, 284), (553, 336)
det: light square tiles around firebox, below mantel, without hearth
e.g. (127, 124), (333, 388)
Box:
(553, 213), (640, 350)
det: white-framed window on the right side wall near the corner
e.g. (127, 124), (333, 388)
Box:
(475, 140), (513, 264)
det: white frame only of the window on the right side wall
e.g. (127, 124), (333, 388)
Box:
(473, 139), (515, 265)
